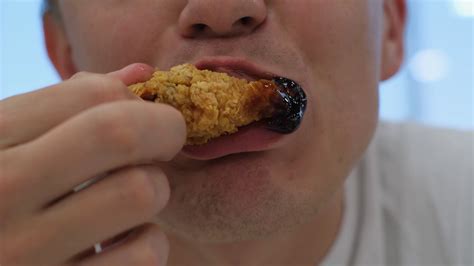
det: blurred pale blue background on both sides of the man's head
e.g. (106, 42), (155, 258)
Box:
(0, 0), (474, 129)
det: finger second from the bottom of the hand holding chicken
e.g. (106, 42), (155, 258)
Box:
(5, 166), (170, 265)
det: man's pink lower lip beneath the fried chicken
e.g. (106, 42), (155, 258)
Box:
(181, 123), (285, 160)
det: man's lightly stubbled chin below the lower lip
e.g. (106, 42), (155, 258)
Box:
(156, 145), (318, 243)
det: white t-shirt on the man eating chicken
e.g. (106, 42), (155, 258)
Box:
(322, 123), (474, 266)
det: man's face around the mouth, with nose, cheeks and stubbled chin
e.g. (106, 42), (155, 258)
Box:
(53, 0), (392, 241)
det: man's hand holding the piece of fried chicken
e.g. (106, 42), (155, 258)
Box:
(0, 64), (186, 266)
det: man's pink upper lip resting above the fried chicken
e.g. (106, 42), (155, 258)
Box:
(194, 56), (277, 80)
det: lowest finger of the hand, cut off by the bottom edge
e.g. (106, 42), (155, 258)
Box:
(75, 224), (169, 266)
